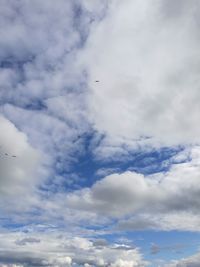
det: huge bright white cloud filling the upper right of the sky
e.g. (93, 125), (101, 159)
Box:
(83, 0), (200, 157)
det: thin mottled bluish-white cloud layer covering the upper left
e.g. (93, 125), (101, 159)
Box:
(0, 0), (94, 185)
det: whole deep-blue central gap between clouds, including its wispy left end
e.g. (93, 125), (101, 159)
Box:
(43, 132), (189, 195)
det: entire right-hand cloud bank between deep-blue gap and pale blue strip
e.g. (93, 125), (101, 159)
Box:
(66, 148), (200, 231)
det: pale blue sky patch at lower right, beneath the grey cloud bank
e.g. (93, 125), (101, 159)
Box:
(101, 231), (200, 266)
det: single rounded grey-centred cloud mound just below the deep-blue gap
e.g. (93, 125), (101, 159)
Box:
(67, 172), (154, 216)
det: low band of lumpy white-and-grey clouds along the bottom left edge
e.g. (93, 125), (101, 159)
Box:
(0, 231), (147, 267)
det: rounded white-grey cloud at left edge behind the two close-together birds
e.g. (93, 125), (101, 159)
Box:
(0, 116), (44, 209)
